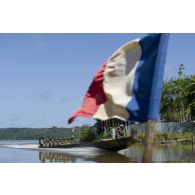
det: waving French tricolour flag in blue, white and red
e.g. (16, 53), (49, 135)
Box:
(68, 33), (169, 124)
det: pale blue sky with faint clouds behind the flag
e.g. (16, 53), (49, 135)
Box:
(0, 33), (195, 128)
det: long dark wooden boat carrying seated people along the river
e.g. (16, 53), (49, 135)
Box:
(39, 136), (136, 151)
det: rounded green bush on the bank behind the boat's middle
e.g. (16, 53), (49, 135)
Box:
(78, 125), (95, 141)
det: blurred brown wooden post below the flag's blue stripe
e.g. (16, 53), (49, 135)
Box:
(143, 120), (156, 163)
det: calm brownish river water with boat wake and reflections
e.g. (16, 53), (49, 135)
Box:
(0, 140), (195, 163)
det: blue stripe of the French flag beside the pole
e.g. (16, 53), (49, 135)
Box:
(126, 34), (169, 122)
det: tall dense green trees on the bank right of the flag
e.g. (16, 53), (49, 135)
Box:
(160, 64), (195, 122)
